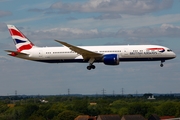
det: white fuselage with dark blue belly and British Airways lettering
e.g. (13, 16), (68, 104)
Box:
(16, 45), (176, 63)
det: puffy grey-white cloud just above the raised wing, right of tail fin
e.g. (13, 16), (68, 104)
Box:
(27, 28), (112, 40)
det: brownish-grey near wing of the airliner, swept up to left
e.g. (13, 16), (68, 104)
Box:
(55, 40), (103, 60)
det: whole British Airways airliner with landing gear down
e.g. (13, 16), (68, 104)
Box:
(5, 25), (176, 70)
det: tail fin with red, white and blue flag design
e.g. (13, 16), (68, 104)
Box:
(7, 25), (34, 52)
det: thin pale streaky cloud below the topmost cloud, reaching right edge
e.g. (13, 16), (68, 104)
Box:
(53, 14), (180, 32)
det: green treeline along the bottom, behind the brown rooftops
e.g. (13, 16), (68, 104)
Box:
(0, 96), (180, 120)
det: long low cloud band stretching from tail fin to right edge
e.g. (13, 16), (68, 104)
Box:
(24, 24), (180, 41)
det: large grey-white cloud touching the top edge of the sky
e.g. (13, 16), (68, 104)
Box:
(47, 0), (173, 15)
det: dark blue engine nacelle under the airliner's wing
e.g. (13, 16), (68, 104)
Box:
(103, 54), (119, 65)
